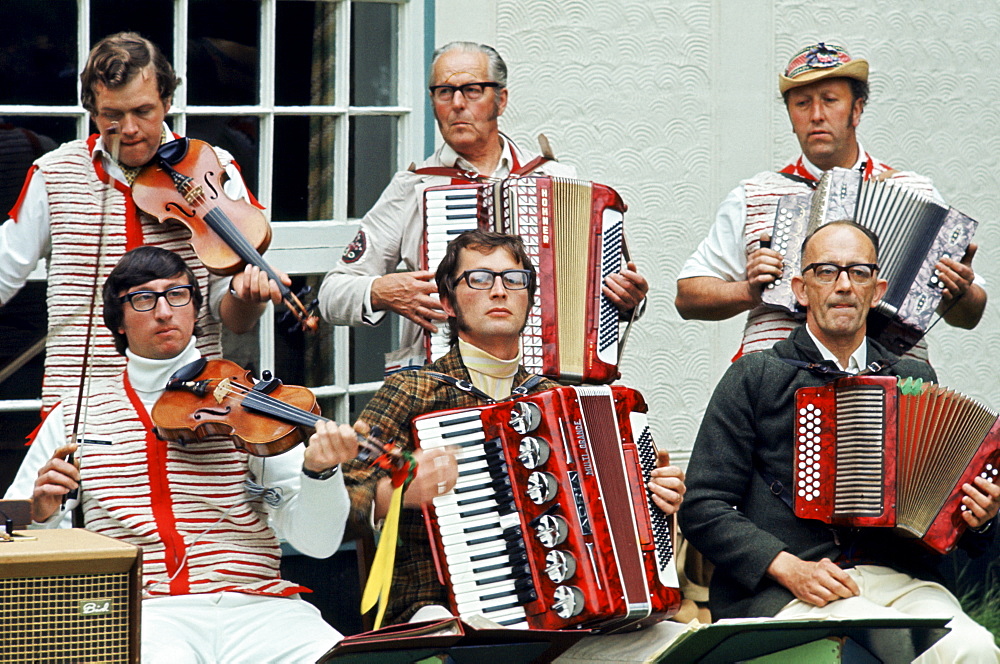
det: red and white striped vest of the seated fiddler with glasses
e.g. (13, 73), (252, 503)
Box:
(66, 373), (307, 596)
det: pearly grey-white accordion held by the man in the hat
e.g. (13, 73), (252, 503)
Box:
(763, 168), (977, 354)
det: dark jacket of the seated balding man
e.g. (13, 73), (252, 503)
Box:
(679, 327), (995, 618)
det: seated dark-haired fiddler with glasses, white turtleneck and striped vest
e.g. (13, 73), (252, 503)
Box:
(7, 247), (358, 663)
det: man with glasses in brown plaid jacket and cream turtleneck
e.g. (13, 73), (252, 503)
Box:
(346, 231), (684, 640)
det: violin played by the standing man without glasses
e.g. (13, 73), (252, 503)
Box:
(132, 137), (319, 332)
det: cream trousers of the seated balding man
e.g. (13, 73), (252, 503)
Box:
(774, 565), (1000, 664)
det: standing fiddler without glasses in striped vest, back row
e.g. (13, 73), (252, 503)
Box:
(0, 32), (280, 411)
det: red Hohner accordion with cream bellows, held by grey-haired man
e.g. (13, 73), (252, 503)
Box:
(421, 176), (628, 383)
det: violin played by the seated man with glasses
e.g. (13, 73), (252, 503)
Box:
(150, 358), (395, 467)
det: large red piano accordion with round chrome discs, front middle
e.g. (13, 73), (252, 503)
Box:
(413, 385), (680, 631)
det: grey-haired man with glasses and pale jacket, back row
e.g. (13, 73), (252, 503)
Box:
(319, 41), (649, 372)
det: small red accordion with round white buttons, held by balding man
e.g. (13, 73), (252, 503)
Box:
(793, 376), (1000, 553)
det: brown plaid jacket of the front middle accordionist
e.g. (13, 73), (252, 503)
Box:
(344, 347), (556, 624)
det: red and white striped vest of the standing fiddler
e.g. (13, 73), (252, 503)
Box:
(36, 135), (223, 412)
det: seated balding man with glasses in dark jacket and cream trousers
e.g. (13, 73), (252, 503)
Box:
(680, 221), (1000, 662)
